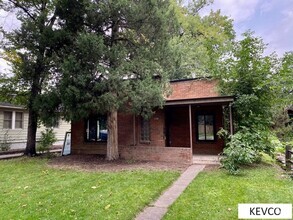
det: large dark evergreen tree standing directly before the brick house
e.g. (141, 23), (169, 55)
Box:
(55, 0), (178, 160)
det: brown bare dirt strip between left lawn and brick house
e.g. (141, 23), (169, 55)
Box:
(49, 155), (188, 172)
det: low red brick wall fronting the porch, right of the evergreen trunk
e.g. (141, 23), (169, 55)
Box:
(119, 146), (192, 164)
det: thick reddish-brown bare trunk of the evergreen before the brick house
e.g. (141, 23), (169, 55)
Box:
(107, 110), (119, 160)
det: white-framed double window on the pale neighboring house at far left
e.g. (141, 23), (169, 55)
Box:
(3, 111), (23, 129)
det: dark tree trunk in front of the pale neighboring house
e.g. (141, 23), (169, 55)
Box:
(24, 108), (38, 157)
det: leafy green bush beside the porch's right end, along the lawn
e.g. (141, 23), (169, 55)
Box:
(219, 127), (274, 174)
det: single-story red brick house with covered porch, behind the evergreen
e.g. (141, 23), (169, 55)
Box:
(71, 79), (233, 163)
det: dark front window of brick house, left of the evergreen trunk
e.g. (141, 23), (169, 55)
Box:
(85, 116), (108, 142)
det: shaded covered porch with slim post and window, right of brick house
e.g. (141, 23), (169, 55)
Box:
(165, 96), (233, 157)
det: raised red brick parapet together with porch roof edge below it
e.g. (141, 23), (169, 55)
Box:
(166, 78), (233, 105)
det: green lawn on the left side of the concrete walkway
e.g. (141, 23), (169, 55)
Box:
(0, 158), (179, 219)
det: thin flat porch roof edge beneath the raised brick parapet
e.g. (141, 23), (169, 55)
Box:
(165, 96), (234, 106)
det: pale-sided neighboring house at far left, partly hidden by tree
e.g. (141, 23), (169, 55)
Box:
(0, 102), (71, 149)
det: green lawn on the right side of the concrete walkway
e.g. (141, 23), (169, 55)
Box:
(164, 164), (293, 220)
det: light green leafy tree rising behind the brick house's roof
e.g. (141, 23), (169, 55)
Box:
(171, 1), (235, 79)
